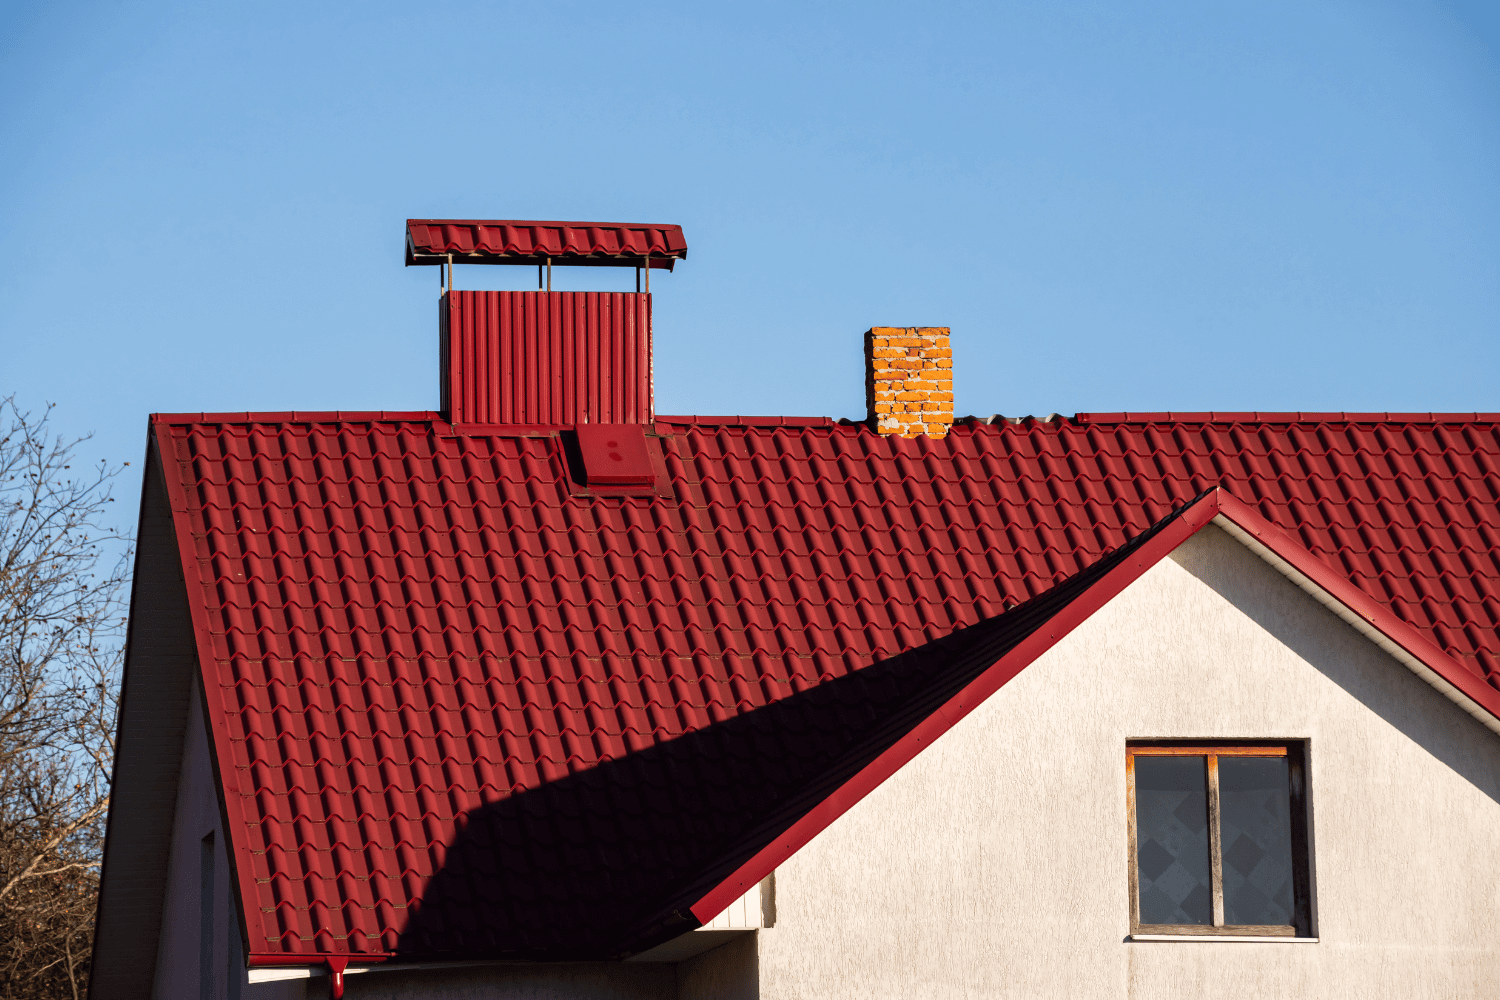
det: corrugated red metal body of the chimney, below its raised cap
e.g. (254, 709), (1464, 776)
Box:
(438, 291), (656, 426)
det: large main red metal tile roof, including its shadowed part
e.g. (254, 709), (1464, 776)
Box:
(155, 414), (1500, 963)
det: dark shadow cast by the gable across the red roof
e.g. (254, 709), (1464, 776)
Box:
(396, 504), (1191, 961)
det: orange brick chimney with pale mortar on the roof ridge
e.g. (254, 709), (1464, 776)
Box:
(864, 327), (953, 438)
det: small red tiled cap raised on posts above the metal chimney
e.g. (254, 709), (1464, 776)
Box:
(407, 219), (687, 270)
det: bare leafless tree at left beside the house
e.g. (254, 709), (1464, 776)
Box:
(0, 396), (129, 1000)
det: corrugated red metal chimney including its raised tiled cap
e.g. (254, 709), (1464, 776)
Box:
(407, 219), (687, 424)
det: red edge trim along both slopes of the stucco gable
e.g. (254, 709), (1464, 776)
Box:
(692, 489), (1500, 924)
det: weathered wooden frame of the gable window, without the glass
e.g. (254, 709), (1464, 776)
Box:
(1125, 739), (1313, 939)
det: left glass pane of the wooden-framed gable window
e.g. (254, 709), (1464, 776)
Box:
(1136, 757), (1214, 924)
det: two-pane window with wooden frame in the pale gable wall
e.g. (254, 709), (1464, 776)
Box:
(1125, 741), (1313, 937)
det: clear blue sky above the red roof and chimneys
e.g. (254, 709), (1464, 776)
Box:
(0, 0), (1500, 520)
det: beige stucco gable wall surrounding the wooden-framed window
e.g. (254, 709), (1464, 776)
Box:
(758, 528), (1500, 1000)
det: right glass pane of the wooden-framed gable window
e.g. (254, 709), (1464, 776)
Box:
(1220, 757), (1292, 925)
